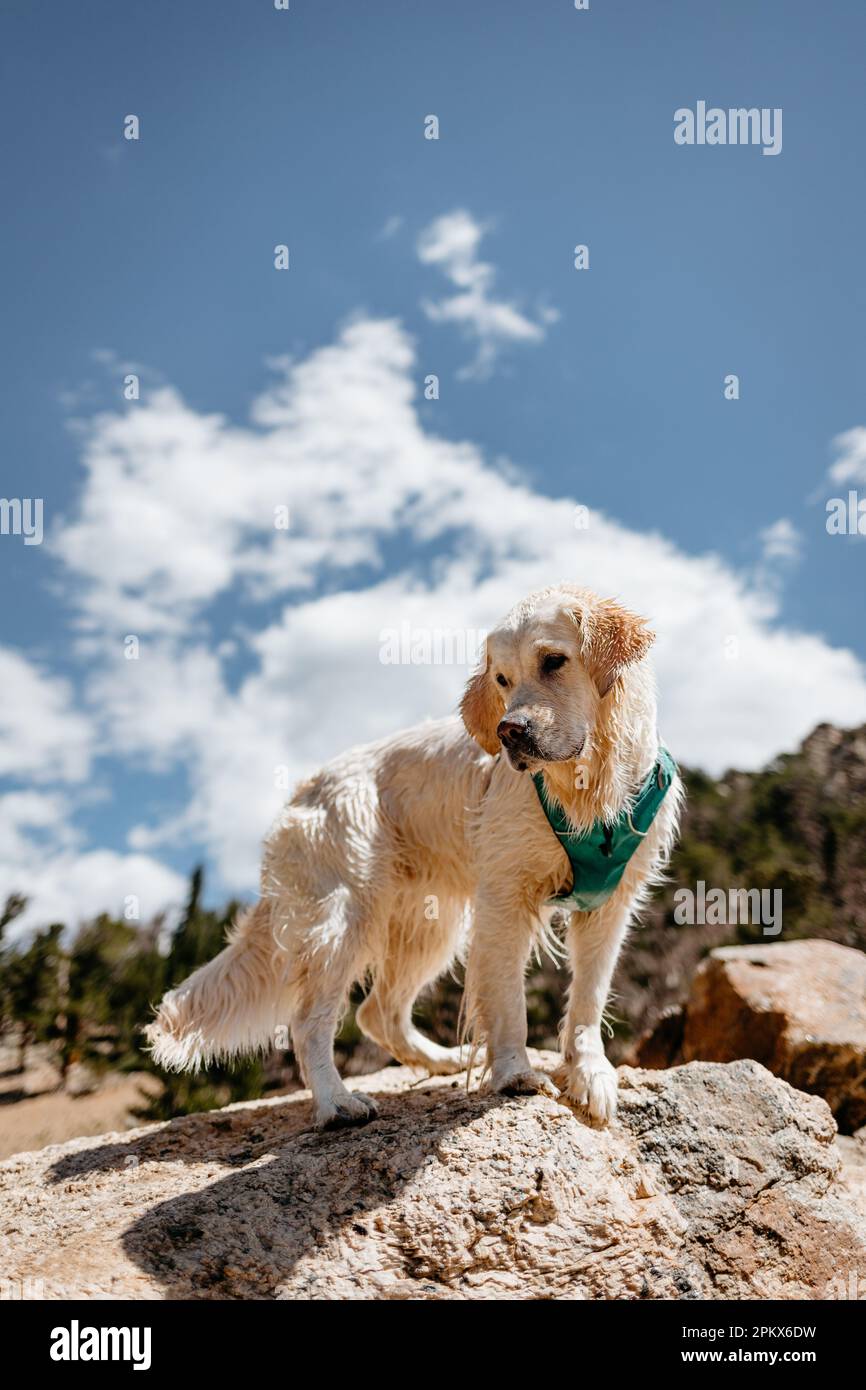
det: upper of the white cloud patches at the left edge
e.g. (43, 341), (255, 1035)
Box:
(0, 648), (92, 783)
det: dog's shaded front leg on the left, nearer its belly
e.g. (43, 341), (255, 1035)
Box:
(464, 895), (559, 1095)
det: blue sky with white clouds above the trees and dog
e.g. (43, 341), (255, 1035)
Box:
(0, 0), (866, 920)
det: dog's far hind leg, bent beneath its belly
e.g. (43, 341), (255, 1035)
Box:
(356, 902), (466, 1076)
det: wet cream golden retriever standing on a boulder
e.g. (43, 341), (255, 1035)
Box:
(146, 585), (683, 1129)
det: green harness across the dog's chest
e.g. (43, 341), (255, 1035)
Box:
(532, 744), (677, 912)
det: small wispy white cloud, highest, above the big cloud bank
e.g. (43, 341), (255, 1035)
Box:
(417, 210), (559, 377)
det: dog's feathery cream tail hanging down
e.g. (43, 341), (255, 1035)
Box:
(145, 899), (289, 1072)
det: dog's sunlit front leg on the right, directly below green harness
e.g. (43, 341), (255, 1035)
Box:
(560, 898), (631, 1125)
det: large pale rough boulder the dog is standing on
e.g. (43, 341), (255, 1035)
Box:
(0, 1054), (866, 1300)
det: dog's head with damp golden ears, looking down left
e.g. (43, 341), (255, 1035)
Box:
(460, 587), (655, 771)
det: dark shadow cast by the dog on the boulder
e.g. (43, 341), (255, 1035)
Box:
(116, 1083), (527, 1300)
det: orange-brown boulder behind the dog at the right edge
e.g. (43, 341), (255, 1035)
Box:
(683, 941), (866, 1133)
